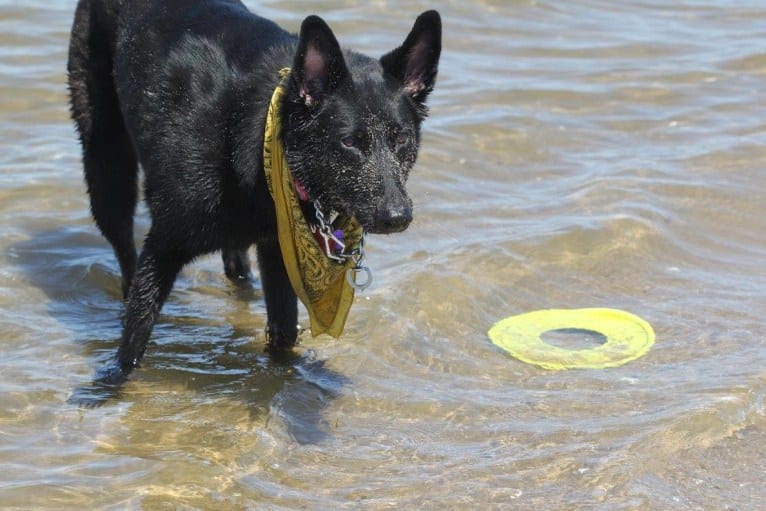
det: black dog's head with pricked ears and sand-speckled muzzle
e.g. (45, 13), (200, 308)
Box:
(282, 11), (441, 233)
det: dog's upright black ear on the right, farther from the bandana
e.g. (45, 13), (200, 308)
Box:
(380, 11), (442, 104)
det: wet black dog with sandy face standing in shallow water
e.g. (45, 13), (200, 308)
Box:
(68, 0), (441, 383)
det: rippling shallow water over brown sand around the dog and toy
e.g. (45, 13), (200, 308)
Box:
(0, 0), (766, 510)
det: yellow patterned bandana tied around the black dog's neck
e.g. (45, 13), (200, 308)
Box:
(263, 68), (363, 337)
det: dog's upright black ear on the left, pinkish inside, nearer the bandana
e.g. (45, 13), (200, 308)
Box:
(292, 16), (348, 107)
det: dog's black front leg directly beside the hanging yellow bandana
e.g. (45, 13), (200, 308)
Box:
(258, 239), (298, 353)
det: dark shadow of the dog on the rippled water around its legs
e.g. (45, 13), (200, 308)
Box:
(11, 226), (348, 443)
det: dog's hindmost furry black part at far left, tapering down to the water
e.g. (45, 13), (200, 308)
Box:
(67, 0), (138, 294)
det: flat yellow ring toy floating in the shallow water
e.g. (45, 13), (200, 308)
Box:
(489, 308), (654, 370)
